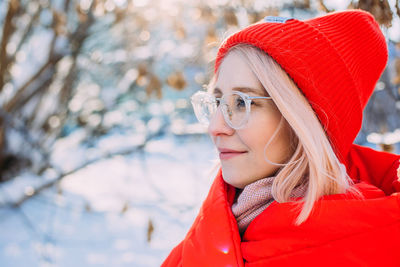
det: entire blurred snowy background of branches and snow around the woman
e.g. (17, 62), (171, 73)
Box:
(0, 0), (400, 267)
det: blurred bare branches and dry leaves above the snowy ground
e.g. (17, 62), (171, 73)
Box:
(0, 0), (400, 188)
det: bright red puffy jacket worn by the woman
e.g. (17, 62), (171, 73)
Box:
(162, 145), (400, 267)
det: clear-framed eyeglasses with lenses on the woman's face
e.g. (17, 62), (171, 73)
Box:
(191, 91), (272, 130)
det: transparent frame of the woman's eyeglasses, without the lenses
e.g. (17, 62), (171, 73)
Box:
(190, 90), (272, 130)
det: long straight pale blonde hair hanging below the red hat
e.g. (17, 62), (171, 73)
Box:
(211, 44), (359, 225)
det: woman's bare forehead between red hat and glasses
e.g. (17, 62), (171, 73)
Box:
(215, 50), (266, 94)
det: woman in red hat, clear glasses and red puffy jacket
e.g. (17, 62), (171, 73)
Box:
(163, 10), (400, 266)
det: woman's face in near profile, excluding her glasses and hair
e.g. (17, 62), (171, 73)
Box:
(208, 51), (292, 188)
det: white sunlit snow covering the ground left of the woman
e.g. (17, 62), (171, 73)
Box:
(0, 135), (216, 267)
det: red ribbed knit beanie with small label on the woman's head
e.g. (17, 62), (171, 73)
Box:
(215, 10), (388, 160)
